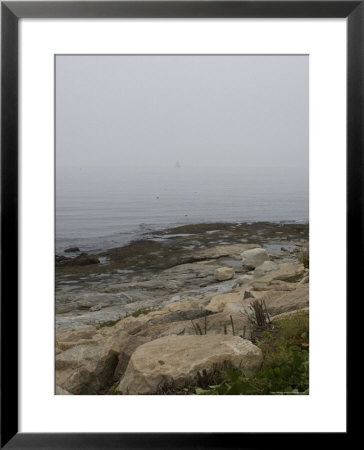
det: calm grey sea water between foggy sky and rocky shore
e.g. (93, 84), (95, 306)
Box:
(56, 167), (308, 254)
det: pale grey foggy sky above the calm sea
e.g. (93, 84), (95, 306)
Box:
(56, 56), (308, 175)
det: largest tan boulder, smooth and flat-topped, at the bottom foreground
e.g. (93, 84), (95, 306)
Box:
(118, 335), (263, 395)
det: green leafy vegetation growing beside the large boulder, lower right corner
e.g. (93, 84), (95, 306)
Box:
(196, 311), (309, 395)
